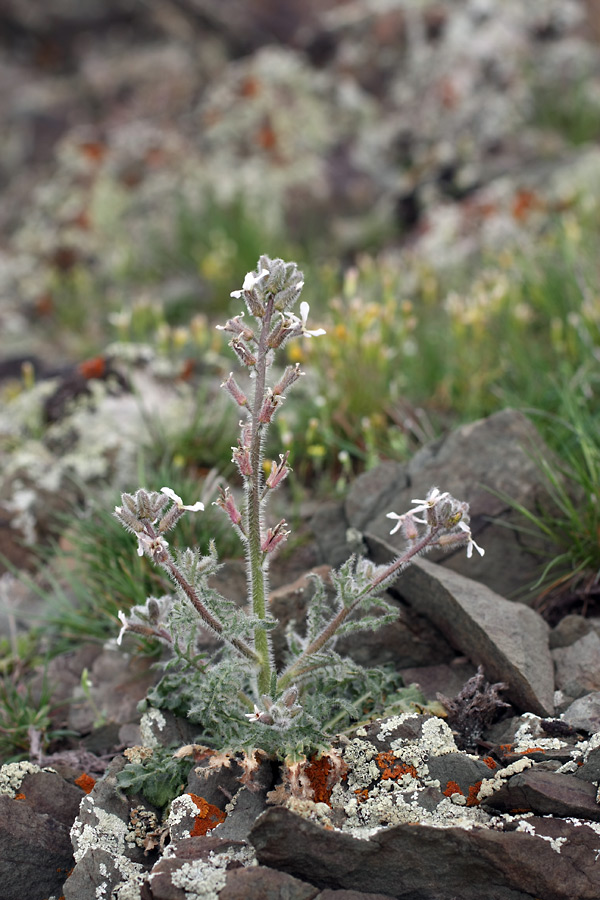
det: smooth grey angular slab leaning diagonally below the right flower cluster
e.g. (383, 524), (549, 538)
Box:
(372, 542), (556, 716)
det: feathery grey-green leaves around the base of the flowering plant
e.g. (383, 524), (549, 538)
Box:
(137, 554), (422, 758)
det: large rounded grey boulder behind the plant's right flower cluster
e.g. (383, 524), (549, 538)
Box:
(345, 409), (564, 597)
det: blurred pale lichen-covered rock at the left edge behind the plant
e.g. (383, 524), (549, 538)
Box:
(0, 368), (202, 562)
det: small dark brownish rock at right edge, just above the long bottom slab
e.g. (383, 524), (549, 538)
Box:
(486, 768), (600, 822)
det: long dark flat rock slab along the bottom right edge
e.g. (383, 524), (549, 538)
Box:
(250, 809), (599, 900)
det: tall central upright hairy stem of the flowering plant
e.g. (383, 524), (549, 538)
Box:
(245, 297), (273, 694)
